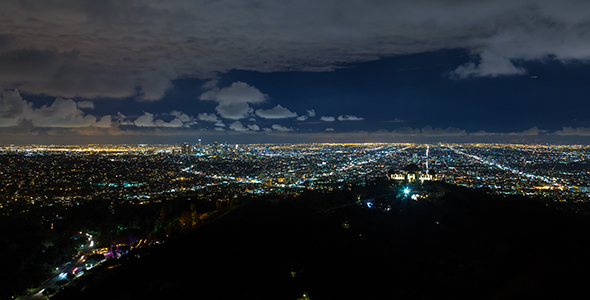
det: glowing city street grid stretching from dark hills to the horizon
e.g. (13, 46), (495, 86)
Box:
(0, 143), (590, 208)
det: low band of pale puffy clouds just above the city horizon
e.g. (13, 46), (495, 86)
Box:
(0, 89), (590, 142)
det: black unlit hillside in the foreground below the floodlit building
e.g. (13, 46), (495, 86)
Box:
(53, 183), (590, 300)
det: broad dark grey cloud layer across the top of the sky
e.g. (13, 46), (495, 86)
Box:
(0, 0), (590, 99)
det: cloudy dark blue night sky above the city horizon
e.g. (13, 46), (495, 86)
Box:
(0, 0), (590, 144)
